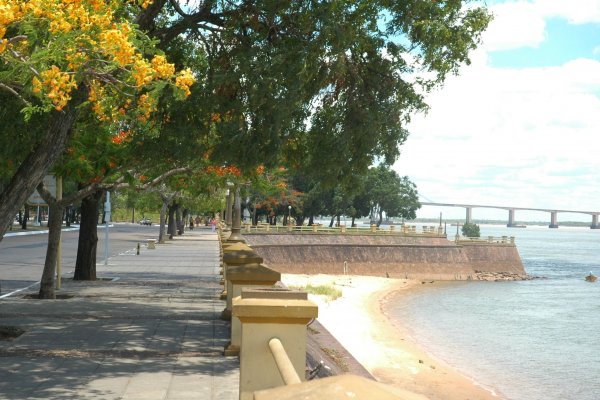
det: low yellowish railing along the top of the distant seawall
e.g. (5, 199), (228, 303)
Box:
(243, 224), (446, 237)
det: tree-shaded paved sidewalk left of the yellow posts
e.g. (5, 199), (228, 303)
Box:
(0, 229), (239, 400)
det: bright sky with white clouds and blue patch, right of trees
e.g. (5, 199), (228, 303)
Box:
(394, 0), (600, 224)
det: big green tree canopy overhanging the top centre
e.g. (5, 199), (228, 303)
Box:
(137, 0), (489, 178)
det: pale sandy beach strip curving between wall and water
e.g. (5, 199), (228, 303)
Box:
(281, 274), (501, 400)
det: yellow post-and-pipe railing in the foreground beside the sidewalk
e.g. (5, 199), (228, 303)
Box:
(219, 230), (426, 400)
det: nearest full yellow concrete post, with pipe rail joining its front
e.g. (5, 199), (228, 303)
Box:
(233, 289), (318, 400)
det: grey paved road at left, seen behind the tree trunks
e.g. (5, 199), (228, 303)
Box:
(0, 223), (158, 296)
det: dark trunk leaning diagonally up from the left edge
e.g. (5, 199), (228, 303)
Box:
(0, 83), (87, 241)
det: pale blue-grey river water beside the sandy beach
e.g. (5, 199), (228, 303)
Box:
(387, 226), (600, 400)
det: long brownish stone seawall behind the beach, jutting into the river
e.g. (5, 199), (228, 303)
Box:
(244, 234), (526, 280)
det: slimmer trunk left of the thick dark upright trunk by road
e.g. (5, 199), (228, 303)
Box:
(38, 202), (64, 299)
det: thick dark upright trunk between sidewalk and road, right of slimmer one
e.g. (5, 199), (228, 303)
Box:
(73, 191), (102, 281)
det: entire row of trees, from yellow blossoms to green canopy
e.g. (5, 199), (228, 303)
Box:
(0, 0), (490, 298)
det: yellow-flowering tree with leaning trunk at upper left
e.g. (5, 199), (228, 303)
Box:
(0, 0), (195, 240)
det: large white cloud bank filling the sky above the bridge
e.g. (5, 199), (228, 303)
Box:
(395, 55), (600, 220)
